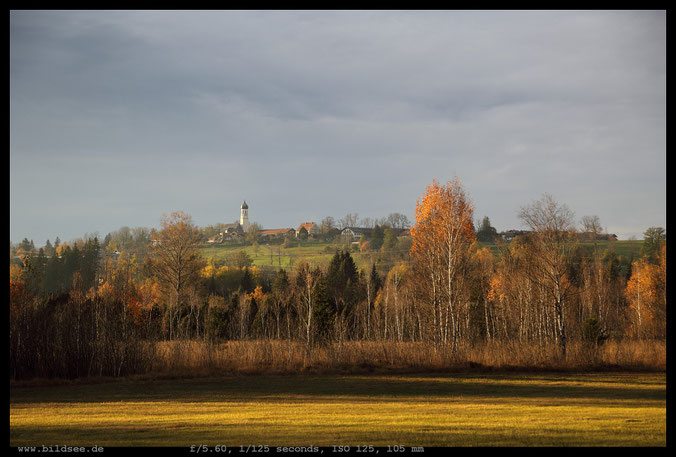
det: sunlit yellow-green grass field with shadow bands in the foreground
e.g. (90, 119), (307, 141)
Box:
(10, 373), (666, 447)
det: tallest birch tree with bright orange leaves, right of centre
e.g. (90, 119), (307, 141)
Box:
(411, 178), (475, 351)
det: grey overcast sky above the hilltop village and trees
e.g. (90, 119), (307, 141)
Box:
(10, 11), (666, 242)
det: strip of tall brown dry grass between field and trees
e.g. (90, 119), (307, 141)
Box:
(145, 340), (666, 376)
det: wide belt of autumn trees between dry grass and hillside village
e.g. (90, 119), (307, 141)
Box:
(10, 179), (666, 378)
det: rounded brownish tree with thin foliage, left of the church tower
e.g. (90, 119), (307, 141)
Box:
(147, 211), (205, 339)
